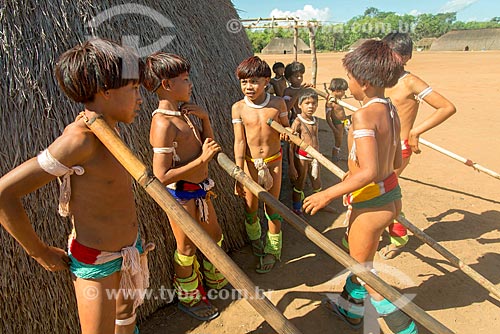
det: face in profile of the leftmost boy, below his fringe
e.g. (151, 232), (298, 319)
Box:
(108, 83), (142, 124)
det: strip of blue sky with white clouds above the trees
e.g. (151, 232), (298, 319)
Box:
(232, 0), (500, 23)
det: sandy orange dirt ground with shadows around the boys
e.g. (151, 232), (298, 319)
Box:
(140, 52), (500, 334)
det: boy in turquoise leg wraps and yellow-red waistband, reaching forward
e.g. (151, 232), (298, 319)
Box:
(304, 40), (418, 334)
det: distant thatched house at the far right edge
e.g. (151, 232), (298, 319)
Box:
(431, 28), (500, 51)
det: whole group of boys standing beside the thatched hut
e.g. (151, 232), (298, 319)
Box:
(0, 30), (454, 333)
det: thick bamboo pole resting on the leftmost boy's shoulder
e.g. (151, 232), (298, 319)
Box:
(85, 117), (301, 334)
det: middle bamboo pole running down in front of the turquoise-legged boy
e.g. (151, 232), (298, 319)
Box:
(217, 153), (453, 333)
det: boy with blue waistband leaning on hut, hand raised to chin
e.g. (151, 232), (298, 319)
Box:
(144, 52), (228, 321)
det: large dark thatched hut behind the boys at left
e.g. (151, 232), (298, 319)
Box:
(0, 0), (252, 334)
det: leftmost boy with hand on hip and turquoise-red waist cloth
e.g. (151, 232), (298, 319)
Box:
(0, 39), (154, 334)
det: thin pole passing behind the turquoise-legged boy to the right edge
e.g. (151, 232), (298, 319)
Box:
(267, 119), (500, 299)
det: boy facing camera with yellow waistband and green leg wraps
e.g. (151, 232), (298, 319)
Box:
(231, 56), (289, 273)
